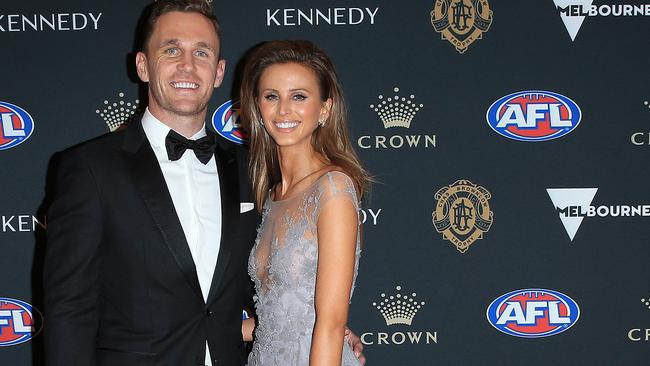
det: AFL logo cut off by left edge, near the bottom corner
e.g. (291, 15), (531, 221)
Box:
(0, 297), (43, 347)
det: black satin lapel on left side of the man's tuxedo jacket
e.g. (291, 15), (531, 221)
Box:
(123, 123), (203, 299)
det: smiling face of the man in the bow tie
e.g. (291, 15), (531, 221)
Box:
(136, 11), (225, 122)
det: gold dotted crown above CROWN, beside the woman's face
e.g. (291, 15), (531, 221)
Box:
(370, 87), (424, 128)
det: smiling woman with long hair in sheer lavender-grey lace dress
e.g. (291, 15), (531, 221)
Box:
(241, 41), (369, 366)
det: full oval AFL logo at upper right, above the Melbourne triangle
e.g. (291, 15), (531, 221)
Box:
(486, 90), (582, 141)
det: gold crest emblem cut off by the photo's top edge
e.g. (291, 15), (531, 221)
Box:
(431, 0), (492, 53)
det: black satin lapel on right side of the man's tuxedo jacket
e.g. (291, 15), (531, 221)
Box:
(207, 143), (239, 304)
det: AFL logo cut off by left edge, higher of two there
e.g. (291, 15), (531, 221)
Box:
(0, 102), (34, 150)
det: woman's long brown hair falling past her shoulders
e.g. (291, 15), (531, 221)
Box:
(240, 40), (370, 209)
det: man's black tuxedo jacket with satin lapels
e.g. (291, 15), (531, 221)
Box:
(44, 123), (259, 366)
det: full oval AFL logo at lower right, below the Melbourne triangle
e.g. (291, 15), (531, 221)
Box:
(487, 289), (580, 338)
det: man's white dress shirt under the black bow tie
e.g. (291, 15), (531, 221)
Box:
(142, 108), (221, 366)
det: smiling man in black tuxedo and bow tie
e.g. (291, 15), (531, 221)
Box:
(44, 0), (362, 366)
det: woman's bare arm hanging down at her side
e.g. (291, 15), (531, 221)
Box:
(309, 195), (359, 366)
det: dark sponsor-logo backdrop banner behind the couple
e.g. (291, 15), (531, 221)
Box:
(0, 0), (650, 366)
